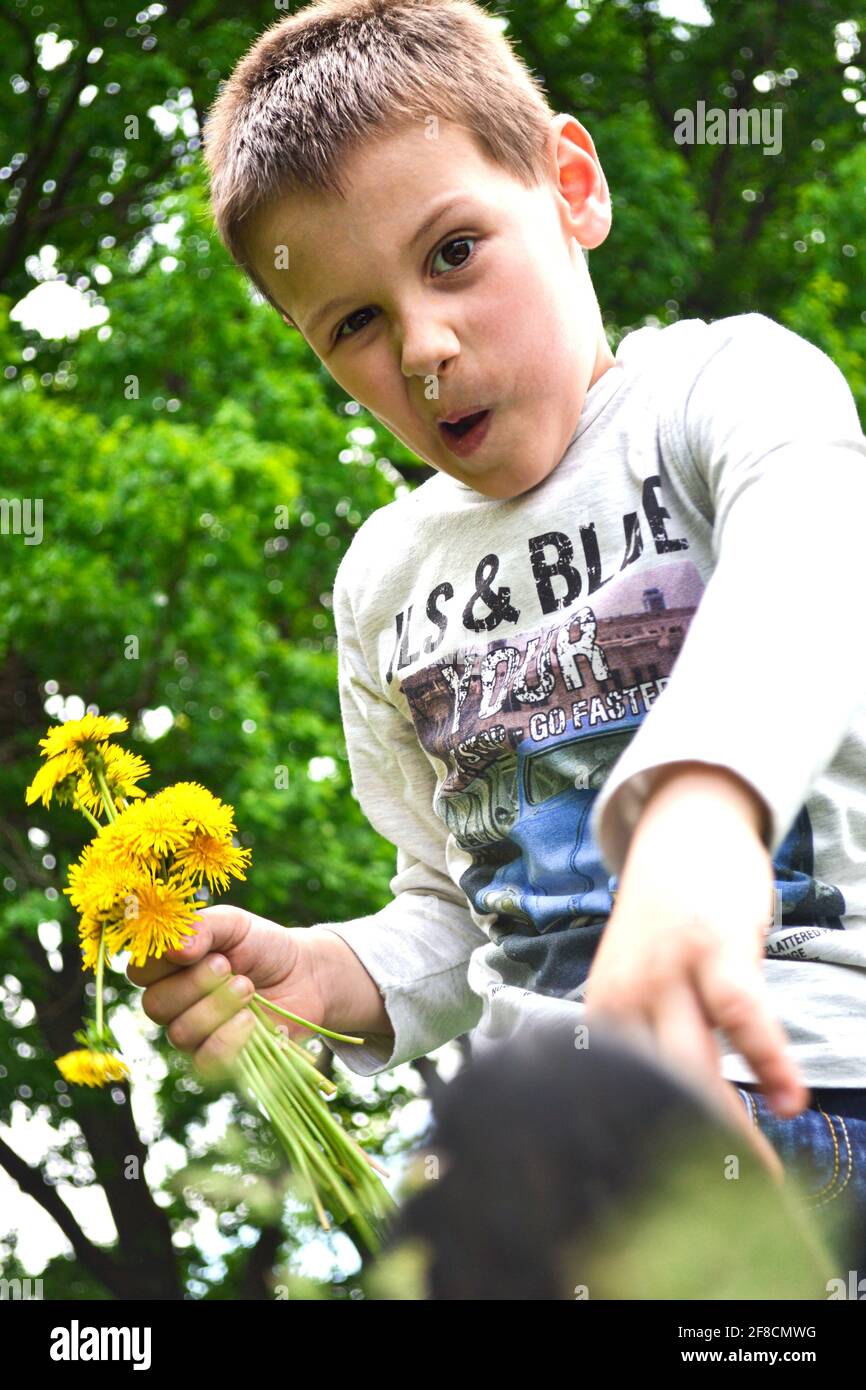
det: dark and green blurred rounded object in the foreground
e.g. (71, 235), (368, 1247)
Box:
(373, 1027), (837, 1301)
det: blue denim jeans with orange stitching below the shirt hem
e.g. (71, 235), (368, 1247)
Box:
(737, 1083), (866, 1298)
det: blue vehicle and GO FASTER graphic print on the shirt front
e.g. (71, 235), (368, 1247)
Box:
(388, 542), (844, 998)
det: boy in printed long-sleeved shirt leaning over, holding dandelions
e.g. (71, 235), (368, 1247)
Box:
(129, 0), (866, 1186)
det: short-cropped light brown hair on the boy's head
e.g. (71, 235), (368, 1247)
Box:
(203, 0), (553, 317)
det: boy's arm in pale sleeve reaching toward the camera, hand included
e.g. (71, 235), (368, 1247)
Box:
(587, 314), (866, 1113)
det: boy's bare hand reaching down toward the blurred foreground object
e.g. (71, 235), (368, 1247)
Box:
(585, 763), (809, 1139)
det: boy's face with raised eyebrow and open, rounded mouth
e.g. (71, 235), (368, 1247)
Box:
(245, 115), (613, 498)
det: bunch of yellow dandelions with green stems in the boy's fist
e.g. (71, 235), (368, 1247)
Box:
(26, 714), (393, 1250)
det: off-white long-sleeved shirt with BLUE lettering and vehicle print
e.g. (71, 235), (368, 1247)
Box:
(315, 314), (866, 1087)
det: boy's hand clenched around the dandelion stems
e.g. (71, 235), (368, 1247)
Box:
(126, 905), (327, 1077)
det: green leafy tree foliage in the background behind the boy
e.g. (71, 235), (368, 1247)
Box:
(0, 0), (866, 1298)
